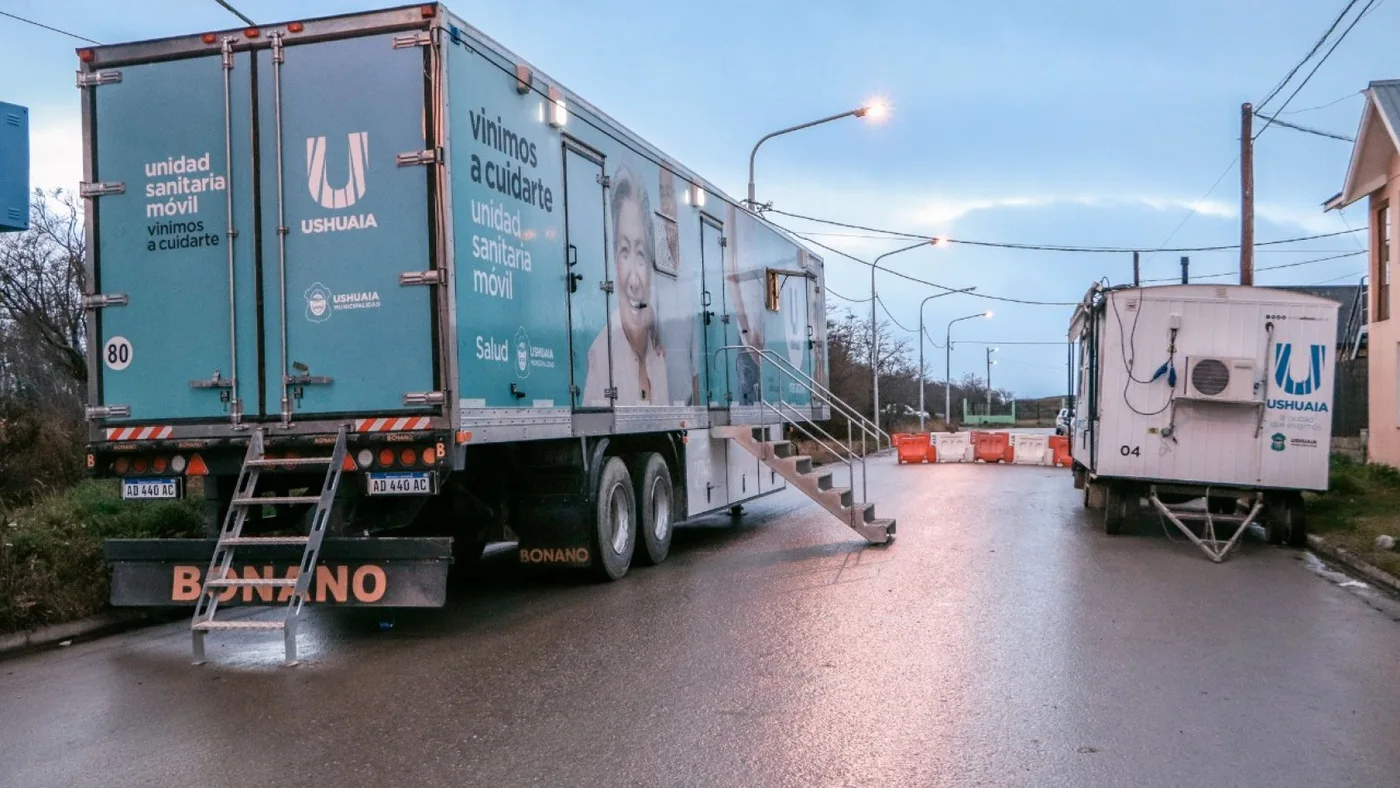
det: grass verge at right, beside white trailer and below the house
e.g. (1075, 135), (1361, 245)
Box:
(1305, 455), (1400, 574)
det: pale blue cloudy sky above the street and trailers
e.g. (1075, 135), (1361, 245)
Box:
(0, 0), (1400, 396)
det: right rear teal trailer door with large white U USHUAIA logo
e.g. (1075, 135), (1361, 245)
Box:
(258, 34), (444, 417)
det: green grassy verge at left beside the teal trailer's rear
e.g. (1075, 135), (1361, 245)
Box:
(0, 480), (202, 633)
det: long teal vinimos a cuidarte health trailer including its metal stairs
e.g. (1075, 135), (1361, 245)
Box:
(78, 4), (895, 661)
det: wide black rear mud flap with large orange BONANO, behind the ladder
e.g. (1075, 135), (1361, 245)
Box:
(104, 537), (452, 607)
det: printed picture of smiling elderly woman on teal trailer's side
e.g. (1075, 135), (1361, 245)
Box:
(584, 167), (671, 406)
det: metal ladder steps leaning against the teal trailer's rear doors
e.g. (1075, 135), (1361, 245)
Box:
(190, 427), (346, 666)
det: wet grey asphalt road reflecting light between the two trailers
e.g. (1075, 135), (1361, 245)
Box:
(0, 458), (1400, 788)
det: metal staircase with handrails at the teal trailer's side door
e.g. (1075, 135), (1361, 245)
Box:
(710, 344), (895, 544)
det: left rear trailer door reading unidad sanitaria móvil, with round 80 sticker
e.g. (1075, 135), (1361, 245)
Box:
(83, 48), (258, 431)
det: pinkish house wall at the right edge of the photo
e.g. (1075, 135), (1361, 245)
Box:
(1366, 155), (1400, 466)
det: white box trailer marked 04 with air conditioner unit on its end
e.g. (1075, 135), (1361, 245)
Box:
(1070, 284), (1338, 561)
